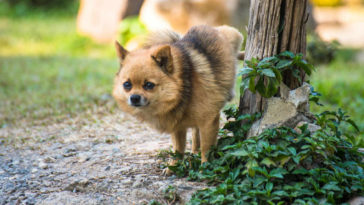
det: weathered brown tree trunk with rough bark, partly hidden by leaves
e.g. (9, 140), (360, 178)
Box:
(239, 0), (308, 114)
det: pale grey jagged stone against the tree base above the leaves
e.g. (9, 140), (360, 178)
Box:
(248, 83), (311, 137)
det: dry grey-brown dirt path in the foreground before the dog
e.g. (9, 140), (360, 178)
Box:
(0, 112), (204, 205)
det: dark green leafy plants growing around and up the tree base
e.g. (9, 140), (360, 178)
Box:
(153, 52), (364, 205)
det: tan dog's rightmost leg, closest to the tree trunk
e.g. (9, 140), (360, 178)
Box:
(200, 114), (220, 163)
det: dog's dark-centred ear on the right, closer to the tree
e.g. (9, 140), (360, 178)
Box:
(151, 45), (173, 74)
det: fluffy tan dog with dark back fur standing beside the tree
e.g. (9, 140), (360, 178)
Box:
(113, 25), (243, 172)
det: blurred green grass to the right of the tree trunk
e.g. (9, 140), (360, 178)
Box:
(311, 49), (364, 147)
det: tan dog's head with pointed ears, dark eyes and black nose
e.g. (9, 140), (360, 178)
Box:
(113, 42), (181, 114)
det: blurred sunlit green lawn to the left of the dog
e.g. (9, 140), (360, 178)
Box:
(0, 10), (118, 127)
